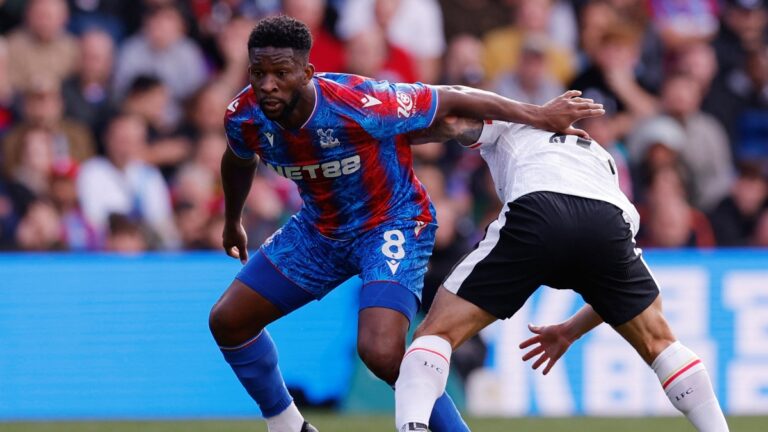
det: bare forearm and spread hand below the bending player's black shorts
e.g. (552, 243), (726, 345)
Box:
(520, 305), (603, 375)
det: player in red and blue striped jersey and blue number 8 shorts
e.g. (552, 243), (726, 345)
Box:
(210, 16), (603, 432)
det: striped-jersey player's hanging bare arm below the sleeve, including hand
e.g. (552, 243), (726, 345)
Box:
(221, 147), (259, 264)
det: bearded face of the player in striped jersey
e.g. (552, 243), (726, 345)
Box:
(248, 47), (313, 120)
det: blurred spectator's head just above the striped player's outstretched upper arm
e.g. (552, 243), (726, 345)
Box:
(440, 34), (486, 87)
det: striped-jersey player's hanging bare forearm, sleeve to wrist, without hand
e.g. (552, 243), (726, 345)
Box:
(221, 150), (258, 223)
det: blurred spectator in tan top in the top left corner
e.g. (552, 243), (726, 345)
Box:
(8, 0), (78, 90)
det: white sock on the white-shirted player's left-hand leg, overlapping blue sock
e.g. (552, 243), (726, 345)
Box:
(395, 336), (452, 431)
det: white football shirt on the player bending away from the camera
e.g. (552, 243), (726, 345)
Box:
(470, 121), (640, 234)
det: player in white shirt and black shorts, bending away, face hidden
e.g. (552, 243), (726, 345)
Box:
(395, 120), (728, 432)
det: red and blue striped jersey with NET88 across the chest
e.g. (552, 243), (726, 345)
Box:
(225, 74), (437, 238)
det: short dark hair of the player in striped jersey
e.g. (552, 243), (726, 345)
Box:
(248, 15), (312, 54)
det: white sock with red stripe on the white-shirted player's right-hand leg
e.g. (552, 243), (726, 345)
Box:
(651, 342), (728, 432)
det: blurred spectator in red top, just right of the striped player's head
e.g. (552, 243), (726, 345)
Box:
(284, 0), (346, 72)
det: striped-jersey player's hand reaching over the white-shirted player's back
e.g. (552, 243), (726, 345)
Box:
(534, 90), (605, 139)
